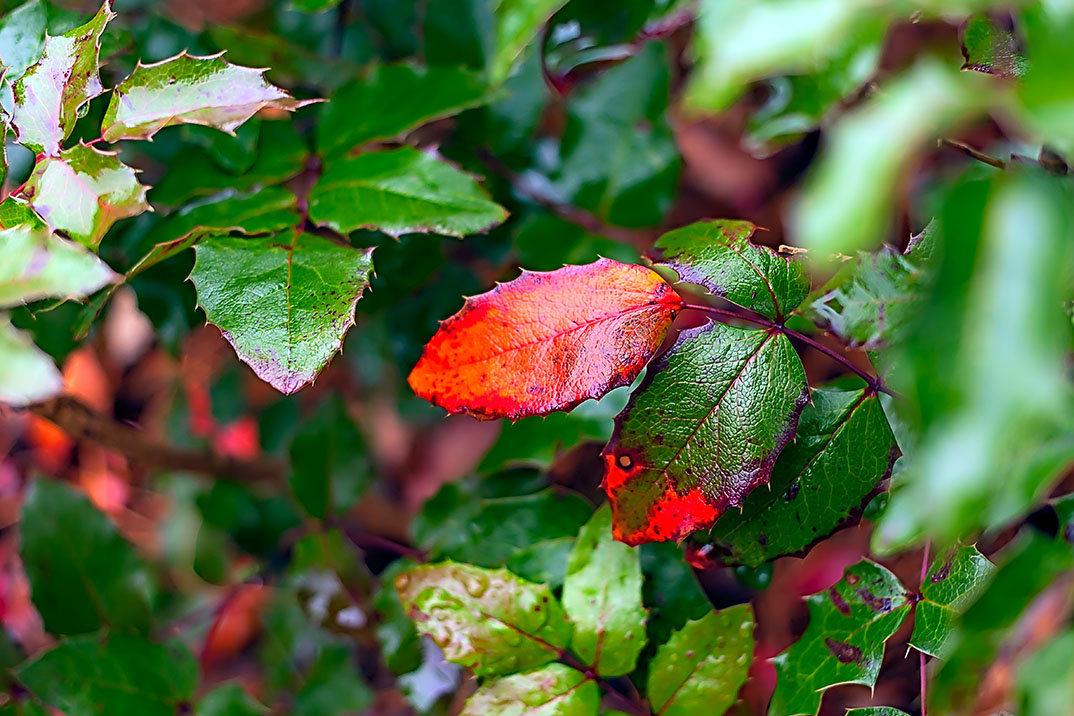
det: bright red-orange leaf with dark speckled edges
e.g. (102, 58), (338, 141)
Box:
(409, 259), (682, 420)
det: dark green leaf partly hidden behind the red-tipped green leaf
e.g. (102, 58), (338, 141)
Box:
(710, 390), (899, 567)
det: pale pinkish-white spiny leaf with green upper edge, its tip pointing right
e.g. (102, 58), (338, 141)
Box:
(101, 53), (319, 142)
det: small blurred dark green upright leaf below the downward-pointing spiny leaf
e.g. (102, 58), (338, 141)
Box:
(288, 397), (369, 520)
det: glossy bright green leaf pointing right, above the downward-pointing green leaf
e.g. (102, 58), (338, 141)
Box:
(309, 147), (507, 236)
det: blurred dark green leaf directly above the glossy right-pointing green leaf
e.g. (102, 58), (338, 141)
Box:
(317, 64), (491, 156)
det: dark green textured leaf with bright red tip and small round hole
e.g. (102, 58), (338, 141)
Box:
(603, 323), (809, 544)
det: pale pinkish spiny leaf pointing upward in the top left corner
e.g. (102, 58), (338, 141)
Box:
(12, 0), (115, 157)
